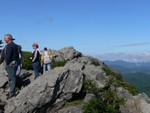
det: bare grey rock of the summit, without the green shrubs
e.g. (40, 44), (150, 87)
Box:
(0, 47), (150, 113)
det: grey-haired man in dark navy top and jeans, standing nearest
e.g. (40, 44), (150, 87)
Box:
(2, 34), (19, 99)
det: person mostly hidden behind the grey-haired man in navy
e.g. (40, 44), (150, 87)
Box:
(16, 45), (24, 76)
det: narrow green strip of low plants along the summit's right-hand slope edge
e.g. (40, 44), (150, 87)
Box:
(103, 66), (138, 95)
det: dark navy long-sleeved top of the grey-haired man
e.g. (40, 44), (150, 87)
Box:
(2, 42), (19, 65)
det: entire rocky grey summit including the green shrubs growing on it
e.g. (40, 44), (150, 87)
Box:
(0, 47), (150, 113)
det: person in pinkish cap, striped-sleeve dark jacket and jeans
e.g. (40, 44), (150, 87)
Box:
(32, 43), (40, 79)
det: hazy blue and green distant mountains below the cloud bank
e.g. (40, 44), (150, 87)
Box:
(104, 60), (150, 97)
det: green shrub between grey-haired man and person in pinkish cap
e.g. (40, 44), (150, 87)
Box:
(22, 51), (33, 70)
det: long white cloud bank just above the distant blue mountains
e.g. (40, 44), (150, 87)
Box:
(96, 53), (150, 62)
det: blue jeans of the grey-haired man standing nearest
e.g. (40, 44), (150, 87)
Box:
(6, 62), (18, 96)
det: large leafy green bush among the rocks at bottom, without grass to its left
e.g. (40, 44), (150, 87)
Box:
(83, 81), (125, 113)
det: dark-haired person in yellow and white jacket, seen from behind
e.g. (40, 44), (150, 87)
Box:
(41, 47), (53, 73)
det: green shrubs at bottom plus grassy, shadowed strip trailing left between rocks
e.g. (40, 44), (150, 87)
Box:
(64, 80), (125, 113)
